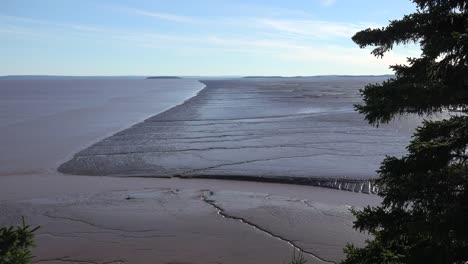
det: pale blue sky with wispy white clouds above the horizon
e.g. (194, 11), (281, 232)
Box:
(0, 0), (420, 76)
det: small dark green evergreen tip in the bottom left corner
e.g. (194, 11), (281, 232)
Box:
(0, 218), (39, 264)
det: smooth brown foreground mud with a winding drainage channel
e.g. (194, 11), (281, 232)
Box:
(0, 174), (379, 264)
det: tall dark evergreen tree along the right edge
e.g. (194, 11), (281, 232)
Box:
(342, 0), (468, 264)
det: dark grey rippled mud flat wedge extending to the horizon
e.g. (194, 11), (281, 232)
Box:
(59, 77), (418, 193)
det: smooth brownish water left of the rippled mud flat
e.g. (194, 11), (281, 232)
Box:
(0, 79), (203, 176)
